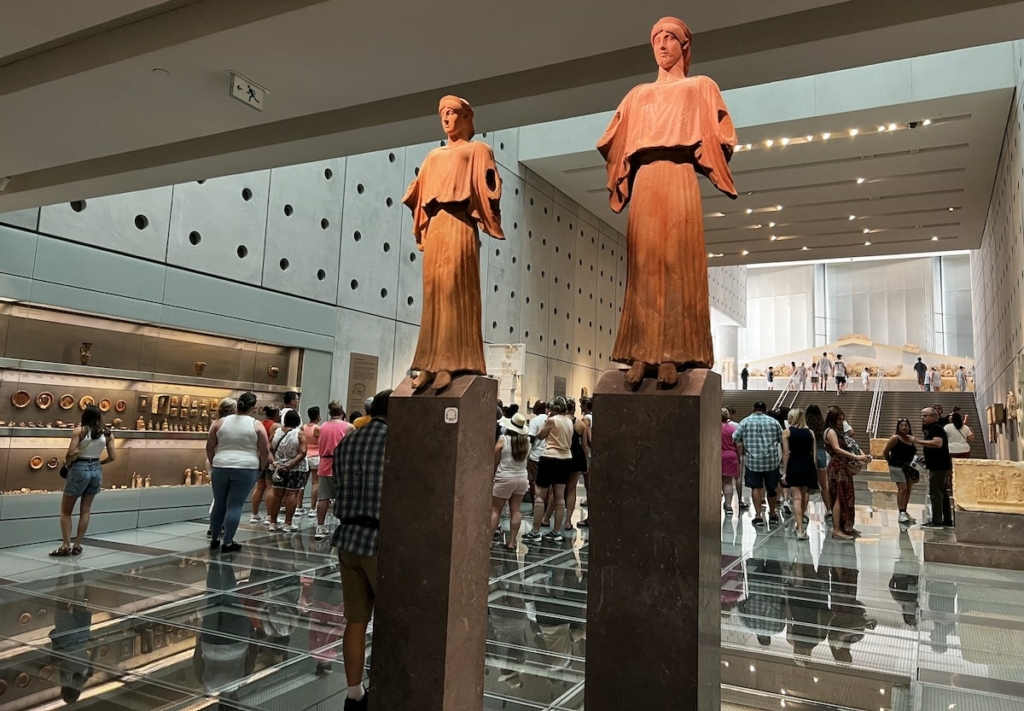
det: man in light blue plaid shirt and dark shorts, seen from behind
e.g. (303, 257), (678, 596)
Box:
(732, 402), (782, 526)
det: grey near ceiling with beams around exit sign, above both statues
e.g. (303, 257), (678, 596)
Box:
(6, 0), (1024, 211)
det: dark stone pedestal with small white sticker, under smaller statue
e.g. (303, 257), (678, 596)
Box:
(370, 376), (498, 711)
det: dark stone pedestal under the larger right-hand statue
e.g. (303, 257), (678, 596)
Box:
(586, 370), (722, 711)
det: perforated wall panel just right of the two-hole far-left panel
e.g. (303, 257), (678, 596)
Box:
(167, 170), (270, 284)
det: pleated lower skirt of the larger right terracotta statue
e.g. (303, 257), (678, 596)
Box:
(611, 160), (715, 368)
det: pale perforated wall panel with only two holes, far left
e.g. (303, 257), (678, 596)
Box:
(39, 187), (171, 261)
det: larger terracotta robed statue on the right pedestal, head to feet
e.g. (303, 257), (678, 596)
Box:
(597, 17), (736, 386)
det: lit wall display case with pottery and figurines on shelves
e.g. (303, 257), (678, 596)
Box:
(0, 303), (302, 494)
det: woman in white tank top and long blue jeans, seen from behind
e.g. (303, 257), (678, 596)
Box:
(206, 392), (270, 553)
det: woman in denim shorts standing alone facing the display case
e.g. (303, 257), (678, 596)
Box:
(50, 405), (117, 557)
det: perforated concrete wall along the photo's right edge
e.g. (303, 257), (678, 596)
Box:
(971, 42), (1024, 459)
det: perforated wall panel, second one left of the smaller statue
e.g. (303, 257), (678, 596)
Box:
(263, 159), (345, 304)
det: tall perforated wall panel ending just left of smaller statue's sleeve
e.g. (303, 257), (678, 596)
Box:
(338, 150), (409, 319)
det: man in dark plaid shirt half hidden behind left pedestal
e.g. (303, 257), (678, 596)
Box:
(331, 390), (391, 711)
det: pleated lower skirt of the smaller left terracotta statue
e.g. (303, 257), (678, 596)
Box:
(413, 209), (487, 375)
